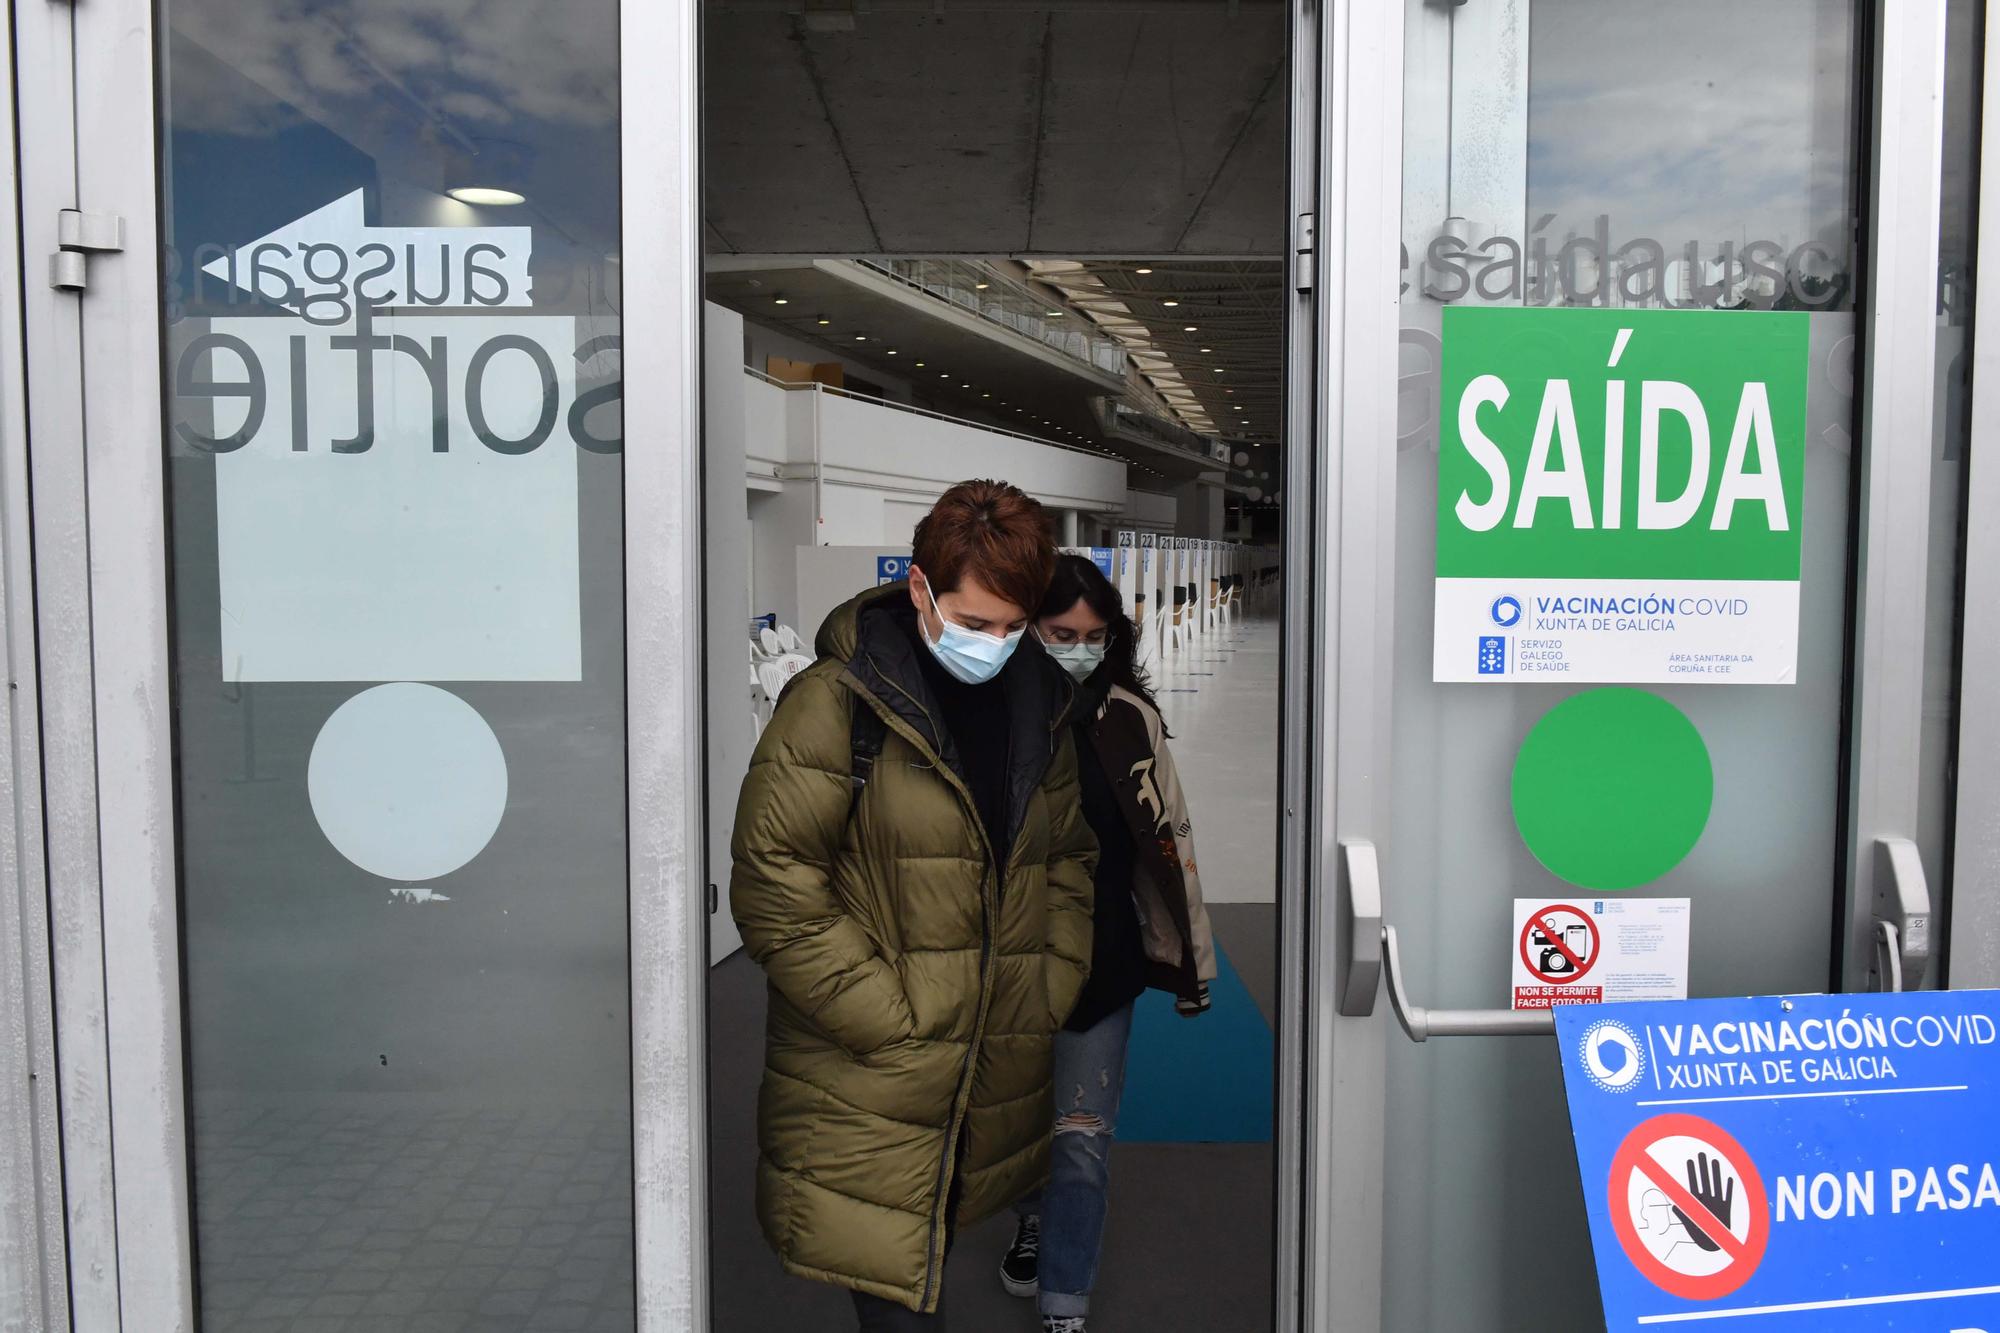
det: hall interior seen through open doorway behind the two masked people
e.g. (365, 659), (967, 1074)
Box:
(704, 0), (1286, 1333)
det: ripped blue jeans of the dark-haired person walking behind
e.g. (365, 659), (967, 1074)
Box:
(1014, 1005), (1132, 1315)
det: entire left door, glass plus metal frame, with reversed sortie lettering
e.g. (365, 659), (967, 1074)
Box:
(16, 0), (704, 1333)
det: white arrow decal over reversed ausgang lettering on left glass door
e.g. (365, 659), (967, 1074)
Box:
(202, 190), (534, 322)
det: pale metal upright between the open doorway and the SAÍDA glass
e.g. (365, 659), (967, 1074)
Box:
(1278, 0), (1404, 1333)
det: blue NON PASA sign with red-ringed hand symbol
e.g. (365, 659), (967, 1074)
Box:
(1556, 991), (2000, 1333)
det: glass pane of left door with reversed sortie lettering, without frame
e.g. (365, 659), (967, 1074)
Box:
(160, 0), (634, 1333)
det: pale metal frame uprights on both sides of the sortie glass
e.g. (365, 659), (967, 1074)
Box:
(0, 0), (708, 1333)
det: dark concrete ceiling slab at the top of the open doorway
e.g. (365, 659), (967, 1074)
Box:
(702, 0), (1288, 256)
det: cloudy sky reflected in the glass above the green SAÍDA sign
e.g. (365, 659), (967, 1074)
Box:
(1528, 0), (1854, 244)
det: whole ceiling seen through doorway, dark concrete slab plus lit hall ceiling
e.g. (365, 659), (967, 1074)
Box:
(704, 0), (1288, 512)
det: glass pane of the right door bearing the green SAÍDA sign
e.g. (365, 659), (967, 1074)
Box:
(1382, 0), (1864, 1333)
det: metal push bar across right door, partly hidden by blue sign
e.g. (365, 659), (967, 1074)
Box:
(1338, 839), (1930, 1041)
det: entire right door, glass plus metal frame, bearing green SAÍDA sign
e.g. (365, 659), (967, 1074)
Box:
(1288, 0), (1944, 1333)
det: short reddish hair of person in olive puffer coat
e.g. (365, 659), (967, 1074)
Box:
(914, 480), (1056, 614)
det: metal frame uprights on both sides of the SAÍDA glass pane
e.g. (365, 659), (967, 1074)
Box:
(1278, 0), (1960, 1333)
